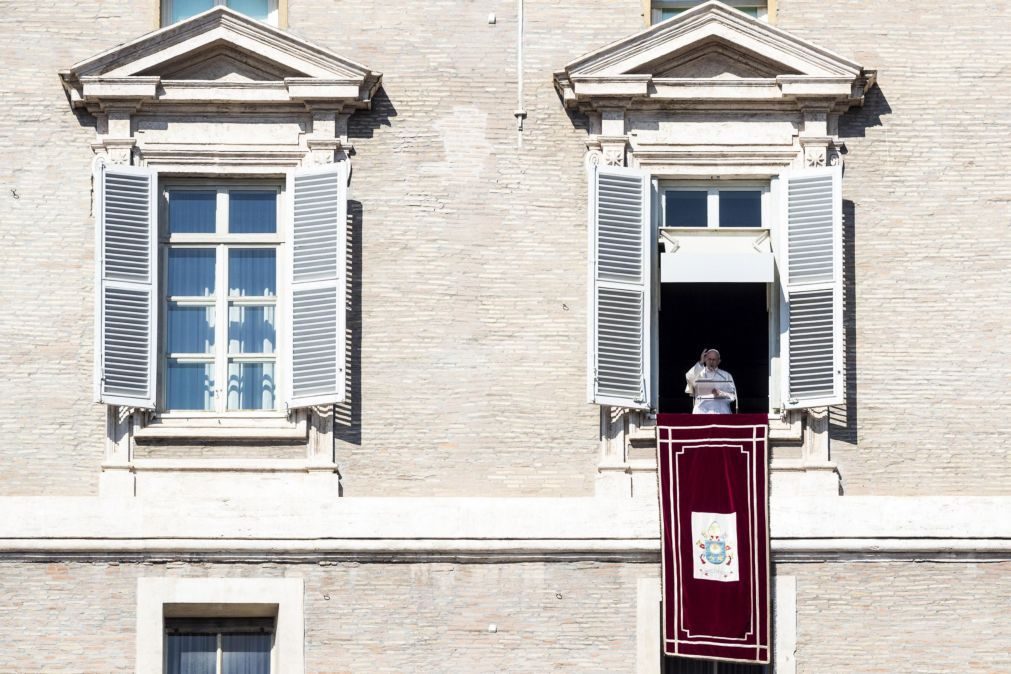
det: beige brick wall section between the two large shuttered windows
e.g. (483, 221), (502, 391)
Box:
(290, 0), (641, 495)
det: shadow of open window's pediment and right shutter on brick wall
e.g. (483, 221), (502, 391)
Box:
(829, 84), (892, 445)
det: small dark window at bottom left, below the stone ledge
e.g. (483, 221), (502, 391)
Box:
(165, 617), (274, 674)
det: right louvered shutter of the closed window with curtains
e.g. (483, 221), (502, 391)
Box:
(287, 161), (348, 408)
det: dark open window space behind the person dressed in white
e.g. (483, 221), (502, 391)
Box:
(659, 283), (769, 413)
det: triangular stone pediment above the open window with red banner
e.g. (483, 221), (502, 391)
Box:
(555, 0), (867, 105)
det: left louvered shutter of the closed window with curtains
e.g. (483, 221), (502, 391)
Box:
(95, 162), (158, 408)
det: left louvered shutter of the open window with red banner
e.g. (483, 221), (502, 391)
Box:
(587, 167), (656, 409)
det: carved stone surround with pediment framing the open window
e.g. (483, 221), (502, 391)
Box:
(554, 0), (878, 496)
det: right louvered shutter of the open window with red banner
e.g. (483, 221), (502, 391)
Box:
(780, 166), (844, 408)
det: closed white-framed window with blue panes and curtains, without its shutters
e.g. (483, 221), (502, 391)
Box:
(161, 185), (282, 412)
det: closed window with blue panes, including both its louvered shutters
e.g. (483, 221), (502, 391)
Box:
(95, 162), (348, 418)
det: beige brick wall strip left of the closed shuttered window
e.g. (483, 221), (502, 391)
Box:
(0, 0), (153, 495)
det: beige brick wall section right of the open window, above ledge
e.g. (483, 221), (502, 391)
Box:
(779, 0), (1011, 494)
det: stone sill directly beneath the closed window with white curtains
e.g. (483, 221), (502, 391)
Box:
(133, 411), (307, 442)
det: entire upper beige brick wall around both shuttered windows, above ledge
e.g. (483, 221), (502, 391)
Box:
(0, 0), (1011, 495)
